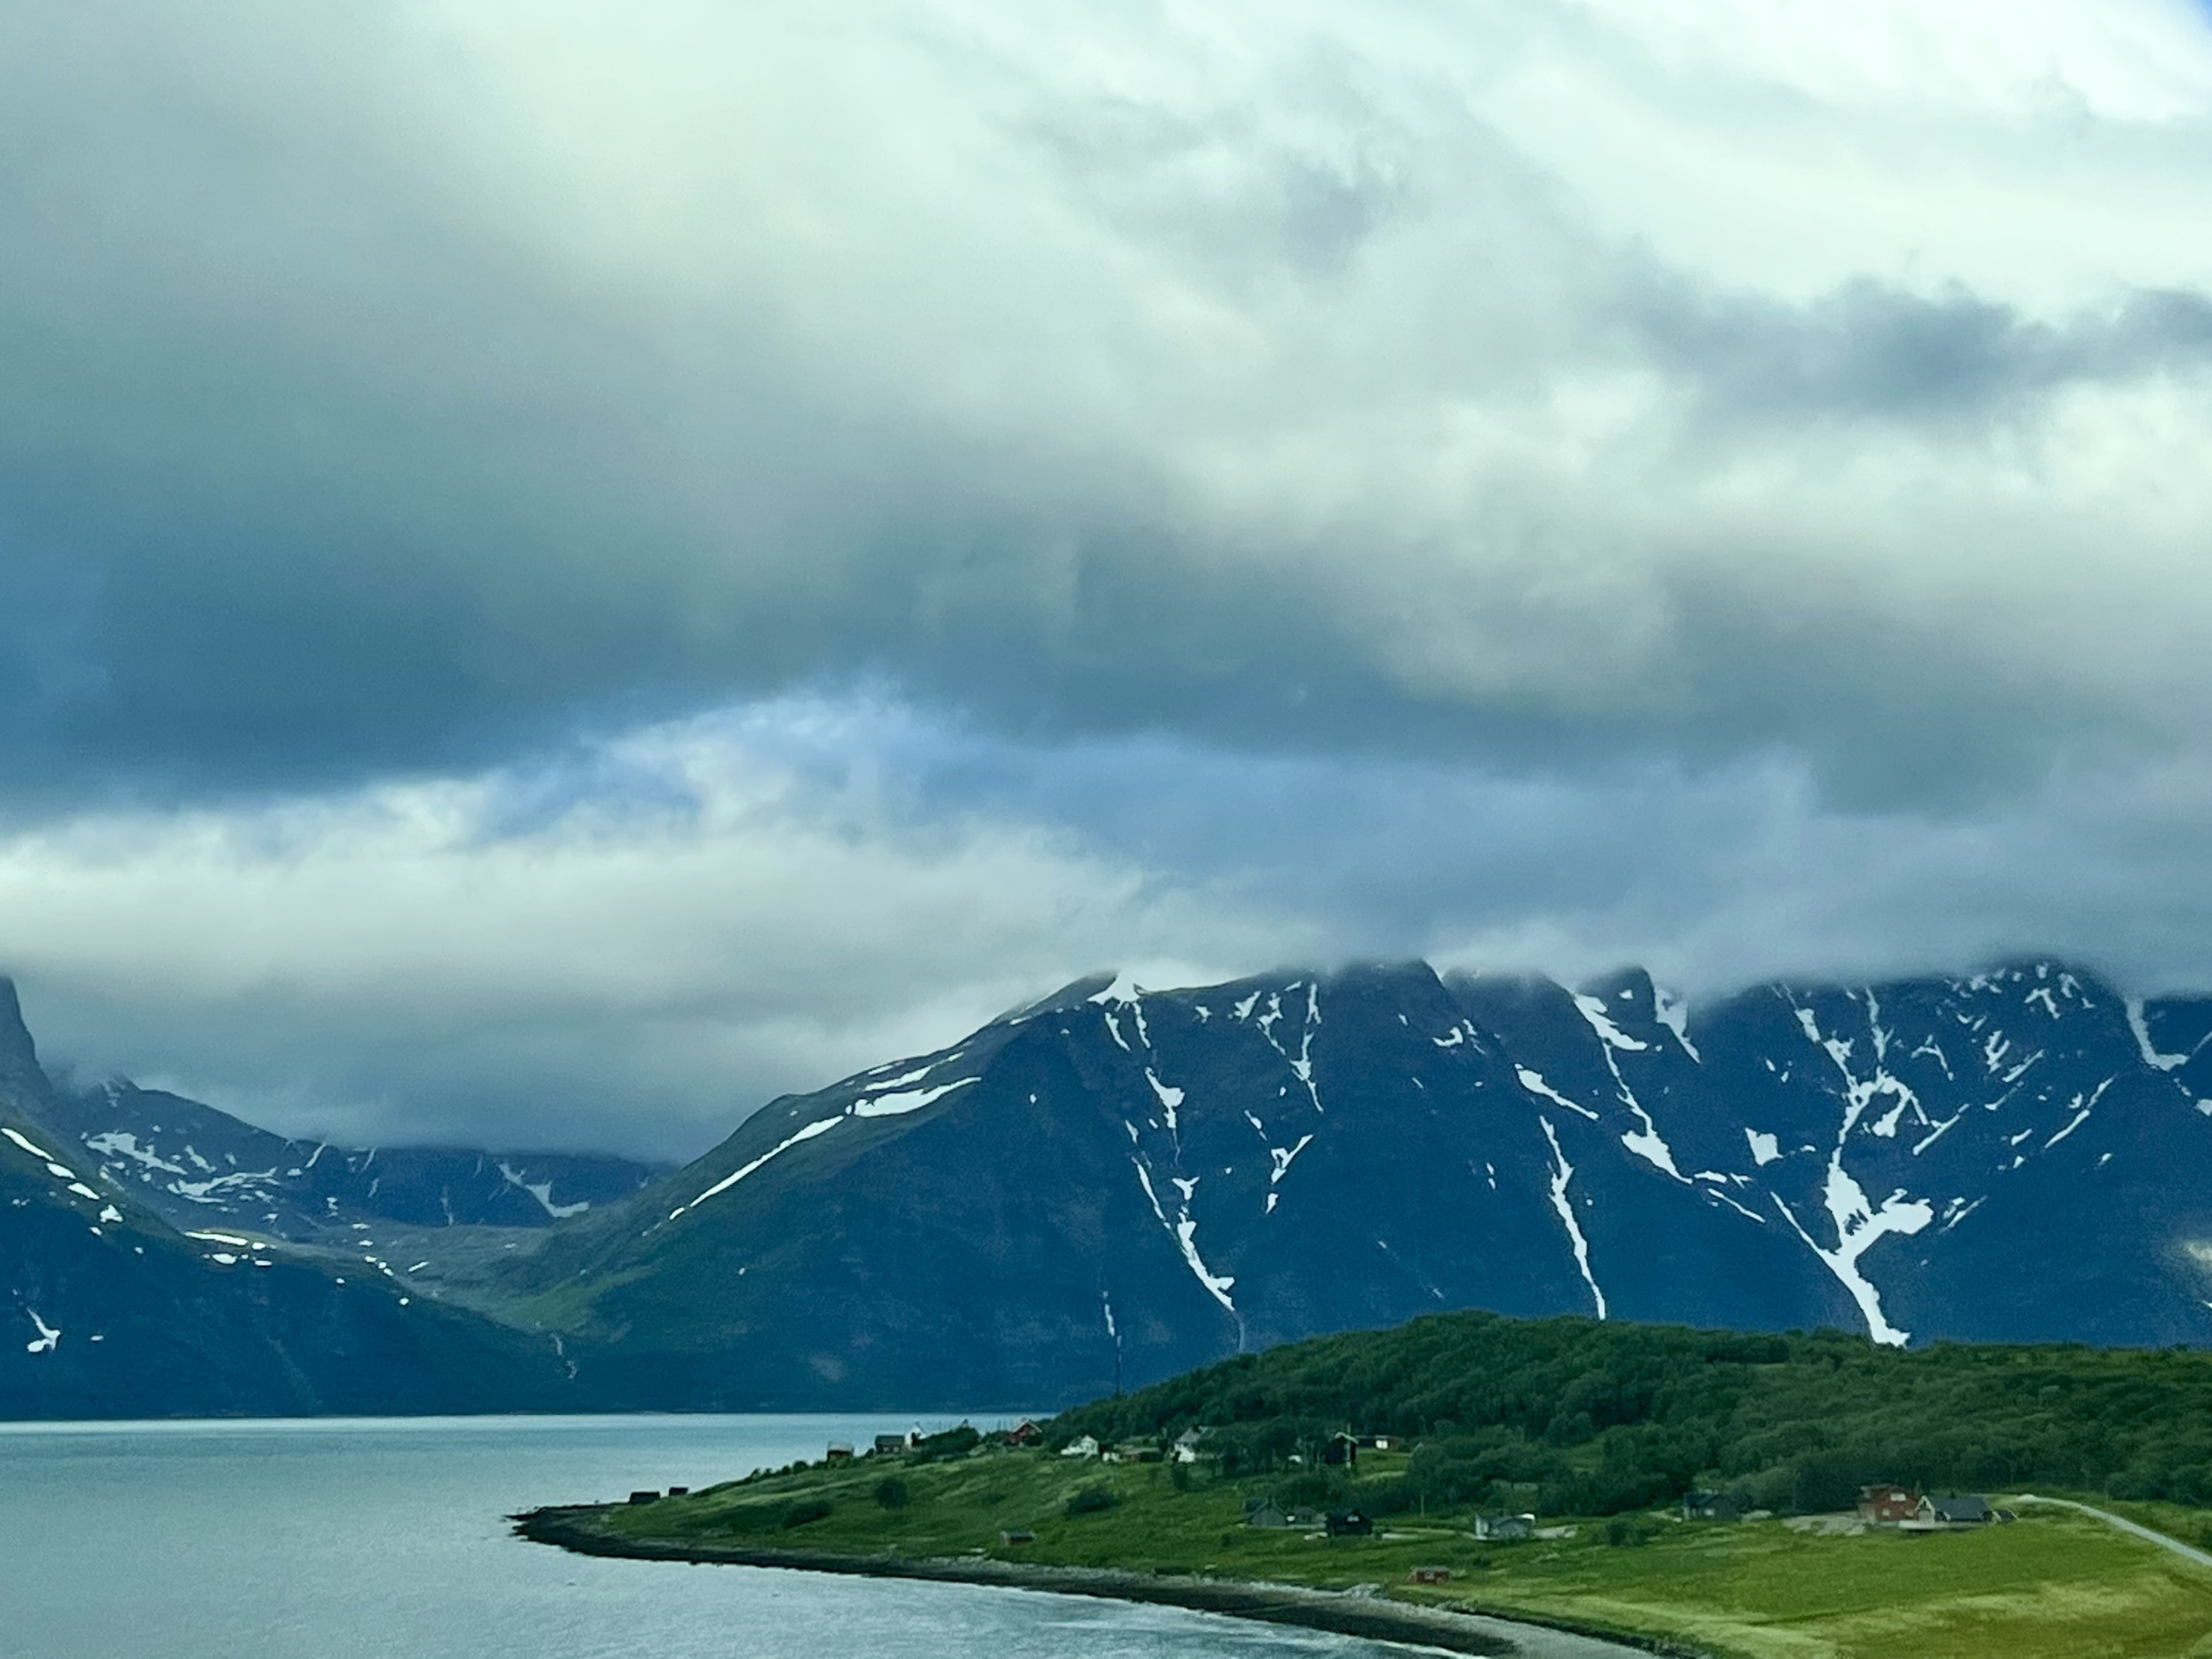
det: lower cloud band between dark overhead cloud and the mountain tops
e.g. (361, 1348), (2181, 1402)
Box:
(13, 699), (2212, 1157)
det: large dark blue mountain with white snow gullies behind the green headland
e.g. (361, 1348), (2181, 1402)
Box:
(509, 962), (2212, 1407)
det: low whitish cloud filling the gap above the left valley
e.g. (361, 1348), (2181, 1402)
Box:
(0, 704), (1316, 1154)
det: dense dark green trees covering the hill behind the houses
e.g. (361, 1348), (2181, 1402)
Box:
(1050, 1312), (2212, 1515)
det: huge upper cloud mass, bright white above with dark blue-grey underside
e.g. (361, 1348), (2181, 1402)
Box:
(0, 0), (2212, 796)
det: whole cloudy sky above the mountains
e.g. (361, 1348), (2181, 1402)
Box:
(0, 0), (2212, 1157)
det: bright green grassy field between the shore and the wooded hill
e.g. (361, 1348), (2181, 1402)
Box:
(608, 1449), (2212, 1659)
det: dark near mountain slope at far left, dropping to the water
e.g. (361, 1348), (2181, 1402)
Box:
(0, 980), (575, 1418)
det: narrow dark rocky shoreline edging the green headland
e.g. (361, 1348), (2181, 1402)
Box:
(509, 1505), (1707, 1659)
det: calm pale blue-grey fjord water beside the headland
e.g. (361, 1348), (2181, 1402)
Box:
(0, 1416), (1385, 1659)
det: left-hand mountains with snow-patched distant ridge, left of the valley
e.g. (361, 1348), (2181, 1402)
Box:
(0, 980), (655, 1418)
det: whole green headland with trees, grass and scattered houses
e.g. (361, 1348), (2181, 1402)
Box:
(520, 1314), (2212, 1659)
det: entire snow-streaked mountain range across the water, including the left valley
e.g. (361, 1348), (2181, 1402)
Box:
(13, 962), (2212, 1416)
